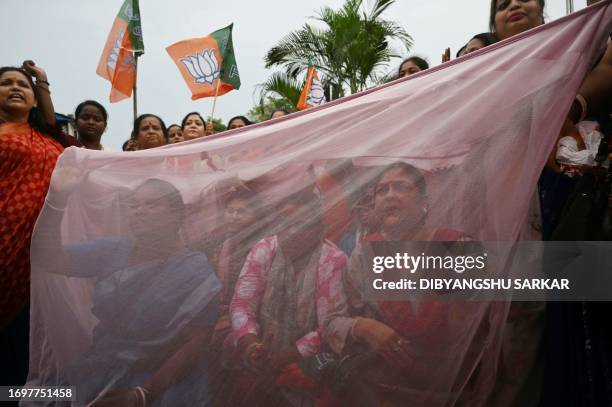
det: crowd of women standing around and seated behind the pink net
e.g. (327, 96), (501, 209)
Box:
(0, 0), (612, 406)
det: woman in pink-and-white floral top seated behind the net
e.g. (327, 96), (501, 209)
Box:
(226, 191), (347, 404)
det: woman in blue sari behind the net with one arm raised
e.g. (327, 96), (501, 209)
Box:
(34, 175), (220, 406)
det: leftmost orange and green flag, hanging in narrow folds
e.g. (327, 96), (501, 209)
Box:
(96, 0), (144, 103)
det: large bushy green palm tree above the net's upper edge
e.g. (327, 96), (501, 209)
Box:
(264, 0), (412, 99)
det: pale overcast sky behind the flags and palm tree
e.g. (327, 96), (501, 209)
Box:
(0, 0), (586, 150)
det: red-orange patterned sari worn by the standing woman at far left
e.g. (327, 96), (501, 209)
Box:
(0, 123), (64, 328)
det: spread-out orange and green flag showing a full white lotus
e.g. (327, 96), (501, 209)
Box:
(166, 24), (240, 100)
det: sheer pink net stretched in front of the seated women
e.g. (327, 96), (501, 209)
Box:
(29, 1), (612, 406)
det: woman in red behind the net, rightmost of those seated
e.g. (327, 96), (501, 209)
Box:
(323, 162), (499, 407)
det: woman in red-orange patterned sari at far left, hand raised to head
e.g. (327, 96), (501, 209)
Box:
(0, 61), (78, 385)
